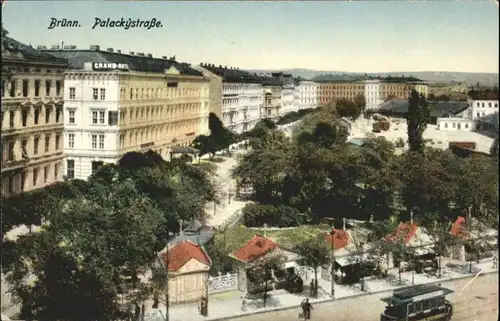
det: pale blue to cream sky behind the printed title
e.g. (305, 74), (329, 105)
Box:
(2, 0), (499, 73)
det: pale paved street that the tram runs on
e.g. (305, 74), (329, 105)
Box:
(227, 273), (498, 321)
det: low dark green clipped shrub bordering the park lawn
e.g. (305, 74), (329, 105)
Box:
(243, 204), (304, 227)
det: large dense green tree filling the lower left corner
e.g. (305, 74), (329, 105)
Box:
(6, 182), (166, 321)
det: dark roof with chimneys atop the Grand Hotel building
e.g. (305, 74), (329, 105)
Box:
(41, 46), (203, 76)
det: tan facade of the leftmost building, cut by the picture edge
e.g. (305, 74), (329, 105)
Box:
(1, 33), (68, 197)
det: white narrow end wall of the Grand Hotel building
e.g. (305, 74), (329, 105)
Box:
(64, 70), (120, 179)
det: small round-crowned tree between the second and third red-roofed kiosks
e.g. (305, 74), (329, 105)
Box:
(296, 235), (331, 296)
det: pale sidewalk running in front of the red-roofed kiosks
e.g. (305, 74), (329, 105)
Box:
(145, 258), (498, 321)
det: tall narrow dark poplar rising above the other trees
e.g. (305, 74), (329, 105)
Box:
(406, 89), (430, 153)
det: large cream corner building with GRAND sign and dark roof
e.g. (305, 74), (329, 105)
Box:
(41, 46), (210, 179)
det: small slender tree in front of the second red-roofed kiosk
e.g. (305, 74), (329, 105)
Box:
(247, 250), (285, 307)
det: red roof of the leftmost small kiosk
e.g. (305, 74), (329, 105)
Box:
(161, 241), (210, 271)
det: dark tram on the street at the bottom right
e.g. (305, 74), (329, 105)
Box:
(380, 284), (453, 321)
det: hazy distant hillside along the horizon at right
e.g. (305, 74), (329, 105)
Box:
(249, 69), (499, 86)
